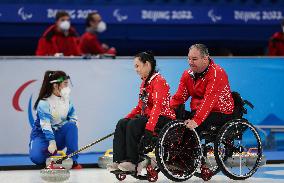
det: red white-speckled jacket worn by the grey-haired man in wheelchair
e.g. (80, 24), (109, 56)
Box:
(171, 60), (234, 125)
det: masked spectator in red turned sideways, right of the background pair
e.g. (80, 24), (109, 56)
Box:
(80, 12), (116, 55)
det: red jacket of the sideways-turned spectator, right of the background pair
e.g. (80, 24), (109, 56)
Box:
(79, 32), (116, 55)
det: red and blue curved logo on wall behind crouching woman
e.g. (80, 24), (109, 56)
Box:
(12, 80), (36, 127)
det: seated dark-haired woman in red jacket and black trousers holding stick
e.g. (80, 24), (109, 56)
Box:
(108, 52), (175, 172)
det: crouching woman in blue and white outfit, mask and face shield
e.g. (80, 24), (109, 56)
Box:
(29, 71), (82, 169)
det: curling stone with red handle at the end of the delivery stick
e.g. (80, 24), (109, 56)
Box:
(40, 162), (70, 182)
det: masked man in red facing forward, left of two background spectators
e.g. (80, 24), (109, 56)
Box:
(36, 11), (81, 56)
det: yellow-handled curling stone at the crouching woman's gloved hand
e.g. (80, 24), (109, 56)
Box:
(45, 151), (73, 170)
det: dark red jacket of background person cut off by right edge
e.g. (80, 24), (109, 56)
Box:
(268, 32), (284, 56)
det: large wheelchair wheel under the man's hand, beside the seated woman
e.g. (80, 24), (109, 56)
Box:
(155, 120), (201, 182)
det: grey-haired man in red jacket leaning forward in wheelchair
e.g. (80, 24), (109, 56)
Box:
(170, 44), (234, 132)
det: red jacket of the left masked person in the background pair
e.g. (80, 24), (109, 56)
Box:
(36, 25), (81, 56)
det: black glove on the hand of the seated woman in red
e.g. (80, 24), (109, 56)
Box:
(139, 130), (157, 154)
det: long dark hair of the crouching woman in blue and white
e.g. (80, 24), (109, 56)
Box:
(34, 71), (68, 110)
